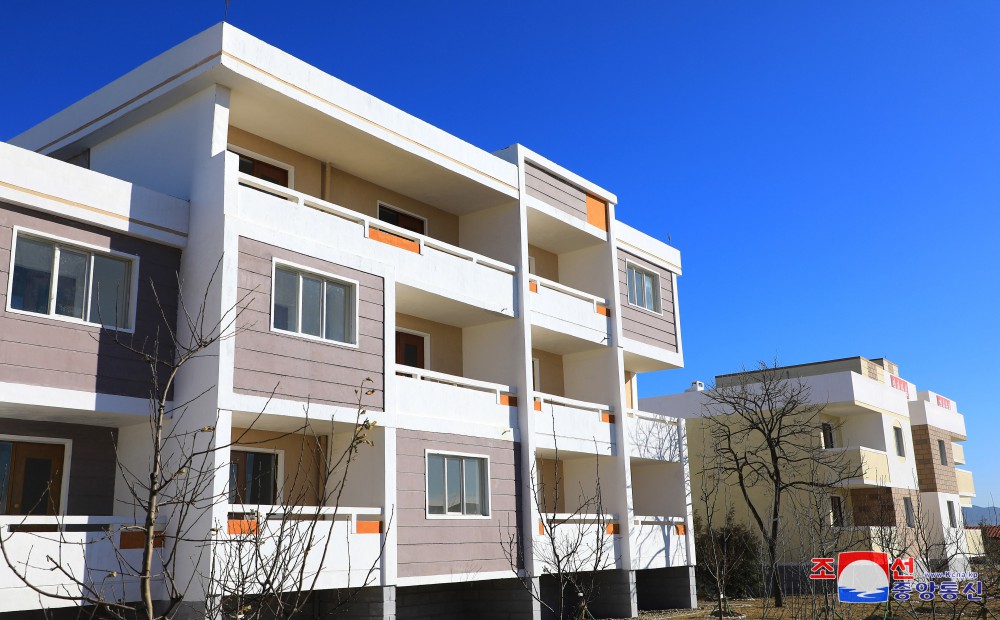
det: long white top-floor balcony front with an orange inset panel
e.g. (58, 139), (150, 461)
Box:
(239, 174), (517, 322)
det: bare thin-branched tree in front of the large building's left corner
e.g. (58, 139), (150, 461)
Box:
(0, 260), (388, 620)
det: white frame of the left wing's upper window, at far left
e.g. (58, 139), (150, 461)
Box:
(6, 226), (140, 334)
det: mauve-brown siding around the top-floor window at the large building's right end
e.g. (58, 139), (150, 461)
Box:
(618, 248), (677, 351)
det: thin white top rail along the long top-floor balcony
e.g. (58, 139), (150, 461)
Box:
(239, 173), (517, 274)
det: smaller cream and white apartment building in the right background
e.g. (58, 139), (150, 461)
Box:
(640, 357), (982, 571)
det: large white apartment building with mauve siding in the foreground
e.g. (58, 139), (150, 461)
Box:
(0, 24), (695, 618)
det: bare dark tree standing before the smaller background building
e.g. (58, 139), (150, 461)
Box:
(704, 362), (860, 607)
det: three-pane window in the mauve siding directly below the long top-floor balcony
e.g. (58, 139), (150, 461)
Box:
(271, 265), (358, 344)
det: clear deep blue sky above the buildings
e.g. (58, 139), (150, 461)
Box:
(0, 0), (1000, 505)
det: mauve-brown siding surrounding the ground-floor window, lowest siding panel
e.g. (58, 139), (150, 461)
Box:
(396, 429), (520, 577)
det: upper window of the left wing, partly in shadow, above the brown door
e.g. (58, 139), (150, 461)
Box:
(9, 232), (137, 329)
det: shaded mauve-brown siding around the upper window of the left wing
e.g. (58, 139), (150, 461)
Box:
(0, 203), (180, 398)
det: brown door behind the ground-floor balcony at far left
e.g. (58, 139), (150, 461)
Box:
(7, 442), (65, 515)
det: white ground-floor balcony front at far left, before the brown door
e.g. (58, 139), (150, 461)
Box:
(0, 516), (166, 613)
